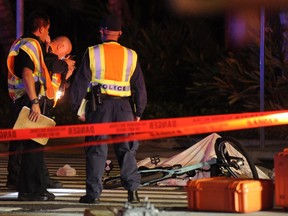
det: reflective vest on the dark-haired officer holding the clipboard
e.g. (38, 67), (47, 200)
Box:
(7, 38), (58, 100)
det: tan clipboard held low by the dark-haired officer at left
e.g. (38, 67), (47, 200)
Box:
(13, 106), (56, 145)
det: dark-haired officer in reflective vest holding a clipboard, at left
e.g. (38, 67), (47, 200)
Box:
(7, 12), (75, 201)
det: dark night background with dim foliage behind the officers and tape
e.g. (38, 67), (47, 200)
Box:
(0, 0), (288, 139)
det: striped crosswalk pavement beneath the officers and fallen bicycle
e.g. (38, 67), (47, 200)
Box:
(0, 134), (288, 216)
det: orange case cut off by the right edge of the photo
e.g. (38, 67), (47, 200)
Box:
(274, 148), (288, 209)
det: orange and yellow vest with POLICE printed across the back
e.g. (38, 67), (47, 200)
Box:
(88, 42), (137, 97)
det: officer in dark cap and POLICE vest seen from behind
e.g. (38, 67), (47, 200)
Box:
(70, 15), (147, 203)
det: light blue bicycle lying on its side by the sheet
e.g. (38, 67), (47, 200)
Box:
(103, 137), (259, 189)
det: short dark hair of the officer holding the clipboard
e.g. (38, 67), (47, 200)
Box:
(25, 11), (50, 32)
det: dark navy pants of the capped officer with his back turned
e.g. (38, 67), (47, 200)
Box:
(85, 99), (141, 198)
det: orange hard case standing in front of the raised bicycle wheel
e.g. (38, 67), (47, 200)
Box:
(187, 177), (274, 212)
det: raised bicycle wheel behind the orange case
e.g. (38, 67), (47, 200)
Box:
(214, 137), (259, 179)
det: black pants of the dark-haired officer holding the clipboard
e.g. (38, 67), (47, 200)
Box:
(7, 96), (47, 193)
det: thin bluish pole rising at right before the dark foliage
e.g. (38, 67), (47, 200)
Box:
(260, 7), (265, 148)
